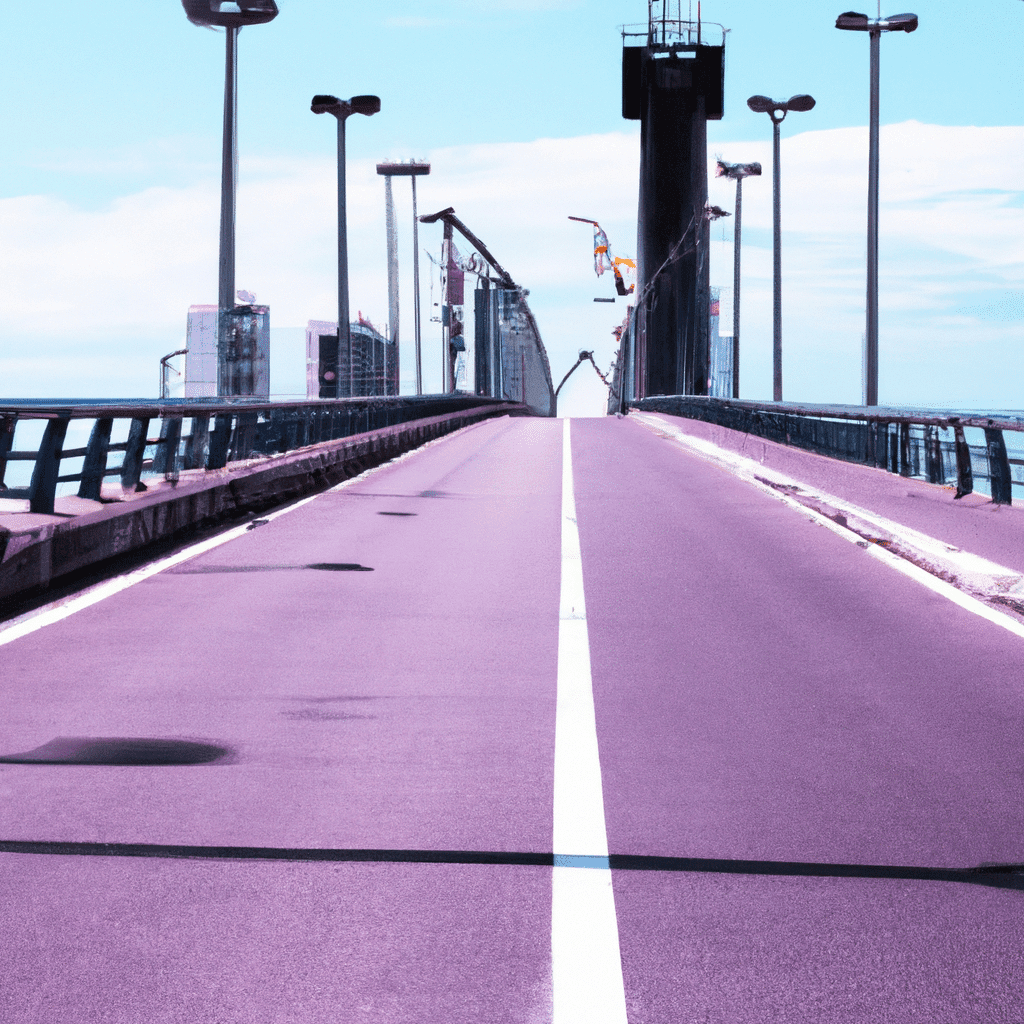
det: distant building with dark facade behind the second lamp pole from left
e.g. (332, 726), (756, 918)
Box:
(306, 318), (398, 398)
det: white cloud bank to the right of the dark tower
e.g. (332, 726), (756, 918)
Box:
(711, 122), (1024, 408)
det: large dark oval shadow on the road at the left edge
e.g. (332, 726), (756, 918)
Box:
(0, 736), (231, 767)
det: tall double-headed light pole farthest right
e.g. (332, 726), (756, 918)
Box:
(836, 12), (918, 406)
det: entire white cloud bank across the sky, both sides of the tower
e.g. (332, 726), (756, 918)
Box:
(0, 122), (1024, 413)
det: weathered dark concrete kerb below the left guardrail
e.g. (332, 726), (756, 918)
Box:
(0, 403), (512, 600)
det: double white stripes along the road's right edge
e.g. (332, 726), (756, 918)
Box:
(632, 414), (1024, 638)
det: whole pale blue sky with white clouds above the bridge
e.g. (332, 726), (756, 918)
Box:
(0, 0), (1024, 410)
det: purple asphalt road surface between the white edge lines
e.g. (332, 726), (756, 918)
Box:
(0, 411), (1024, 1024)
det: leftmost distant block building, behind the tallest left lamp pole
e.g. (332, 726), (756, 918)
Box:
(185, 305), (270, 398)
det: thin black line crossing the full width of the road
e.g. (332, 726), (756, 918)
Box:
(0, 840), (1024, 891)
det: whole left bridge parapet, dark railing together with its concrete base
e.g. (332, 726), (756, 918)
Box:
(0, 395), (528, 617)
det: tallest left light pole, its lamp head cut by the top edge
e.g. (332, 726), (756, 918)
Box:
(181, 0), (278, 395)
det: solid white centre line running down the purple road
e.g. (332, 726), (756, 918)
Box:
(551, 419), (627, 1024)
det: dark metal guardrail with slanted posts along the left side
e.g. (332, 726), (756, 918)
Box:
(0, 394), (512, 513)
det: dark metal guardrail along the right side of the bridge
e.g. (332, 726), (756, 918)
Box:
(630, 395), (1024, 505)
